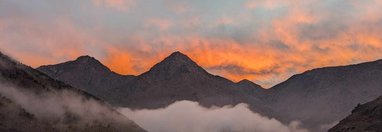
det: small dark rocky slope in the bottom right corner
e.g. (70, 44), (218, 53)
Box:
(329, 96), (382, 132)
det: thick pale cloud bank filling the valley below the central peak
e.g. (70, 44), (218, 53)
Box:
(119, 101), (307, 132)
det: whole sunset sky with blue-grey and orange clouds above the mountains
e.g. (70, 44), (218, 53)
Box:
(0, 0), (382, 88)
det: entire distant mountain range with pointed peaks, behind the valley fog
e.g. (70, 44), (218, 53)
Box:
(37, 52), (382, 131)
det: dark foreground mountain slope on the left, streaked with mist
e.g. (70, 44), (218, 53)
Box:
(0, 52), (145, 132)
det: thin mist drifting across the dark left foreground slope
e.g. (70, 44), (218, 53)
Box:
(0, 82), (138, 131)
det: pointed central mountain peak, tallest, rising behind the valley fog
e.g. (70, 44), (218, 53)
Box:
(120, 52), (268, 111)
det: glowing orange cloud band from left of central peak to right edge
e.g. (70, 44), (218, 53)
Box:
(97, 13), (382, 87)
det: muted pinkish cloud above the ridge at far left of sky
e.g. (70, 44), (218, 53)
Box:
(0, 18), (97, 67)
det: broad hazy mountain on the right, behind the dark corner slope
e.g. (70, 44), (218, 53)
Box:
(266, 60), (382, 131)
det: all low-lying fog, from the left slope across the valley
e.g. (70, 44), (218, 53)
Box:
(0, 82), (332, 132)
